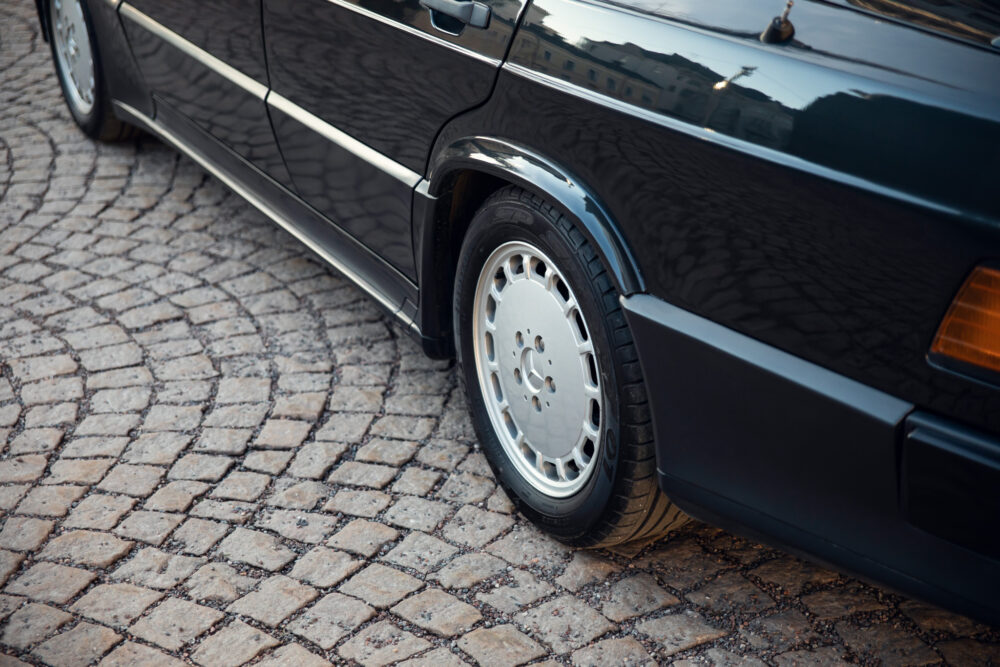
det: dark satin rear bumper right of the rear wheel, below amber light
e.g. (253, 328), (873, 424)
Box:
(622, 295), (1000, 624)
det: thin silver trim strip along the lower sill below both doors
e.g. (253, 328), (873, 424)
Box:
(114, 100), (420, 335)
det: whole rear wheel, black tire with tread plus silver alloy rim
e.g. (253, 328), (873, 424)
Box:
(453, 186), (688, 547)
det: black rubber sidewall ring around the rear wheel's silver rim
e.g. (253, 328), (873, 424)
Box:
(453, 192), (621, 540)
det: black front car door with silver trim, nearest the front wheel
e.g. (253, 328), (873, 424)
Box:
(120, 0), (289, 184)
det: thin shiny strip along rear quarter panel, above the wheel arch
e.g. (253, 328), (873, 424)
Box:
(502, 61), (969, 222)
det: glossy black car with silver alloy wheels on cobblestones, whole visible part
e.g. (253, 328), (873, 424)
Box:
(38, 0), (1000, 623)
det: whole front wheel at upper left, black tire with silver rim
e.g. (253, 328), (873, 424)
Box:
(44, 0), (138, 141)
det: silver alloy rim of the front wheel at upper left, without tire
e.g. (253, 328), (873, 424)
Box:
(49, 0), (97, 116)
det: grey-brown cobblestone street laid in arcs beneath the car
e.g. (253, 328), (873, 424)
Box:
(0, 0), (1000, 667)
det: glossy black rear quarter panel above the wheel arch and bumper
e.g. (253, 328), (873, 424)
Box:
(438, 0), (1000, 431)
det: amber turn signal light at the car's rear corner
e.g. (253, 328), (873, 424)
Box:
(931, 266), (1000, 371)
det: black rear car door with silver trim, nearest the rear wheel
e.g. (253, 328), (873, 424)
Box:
(263, 0), (523, 279)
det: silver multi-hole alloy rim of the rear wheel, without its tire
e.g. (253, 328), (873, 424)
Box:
(472, 241), (604, 498)
